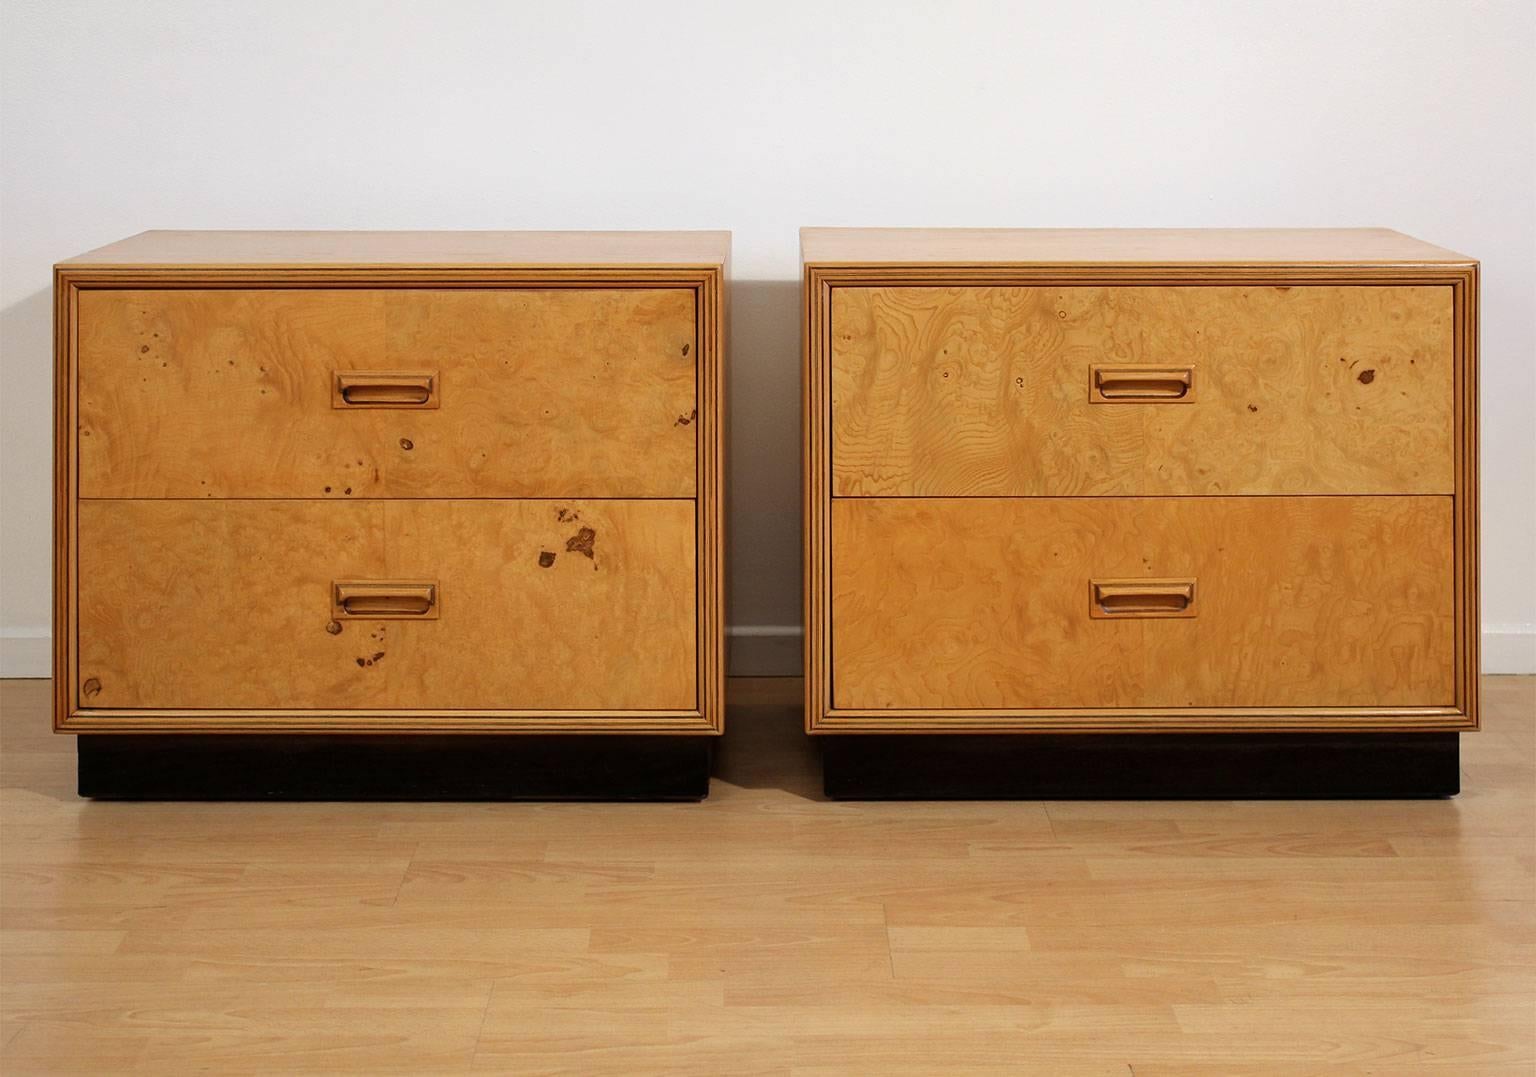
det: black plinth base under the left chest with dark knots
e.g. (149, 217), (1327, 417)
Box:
(77, 733), (714, 800)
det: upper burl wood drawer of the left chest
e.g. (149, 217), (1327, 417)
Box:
(77, 287), (699, 498)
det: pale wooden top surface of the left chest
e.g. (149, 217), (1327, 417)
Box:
(58, 232), (731, 267)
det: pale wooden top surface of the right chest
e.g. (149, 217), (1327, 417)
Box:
(800, 227), (1475, 266)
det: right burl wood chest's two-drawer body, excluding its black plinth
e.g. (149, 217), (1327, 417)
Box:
(802, 229), (1478, 733)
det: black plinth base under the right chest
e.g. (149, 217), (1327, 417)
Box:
(820, 733), (1461, 800)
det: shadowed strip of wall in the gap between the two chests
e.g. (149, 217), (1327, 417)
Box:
(725, 280), (802, 676)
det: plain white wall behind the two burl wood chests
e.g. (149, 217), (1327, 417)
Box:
(0, 0), (1536, 674)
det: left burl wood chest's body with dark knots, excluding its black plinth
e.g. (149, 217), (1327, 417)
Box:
(55, 232), (730, 734)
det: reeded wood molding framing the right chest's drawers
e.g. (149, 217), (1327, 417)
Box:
(802, 256), (1479, 733)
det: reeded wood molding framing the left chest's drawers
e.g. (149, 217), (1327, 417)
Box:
(52, 256), (728, 734)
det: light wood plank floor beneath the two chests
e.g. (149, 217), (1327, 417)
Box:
(0, 678), (1536, 1077)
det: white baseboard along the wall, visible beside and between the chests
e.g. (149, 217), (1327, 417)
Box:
(0, 624), (1536, 678)
